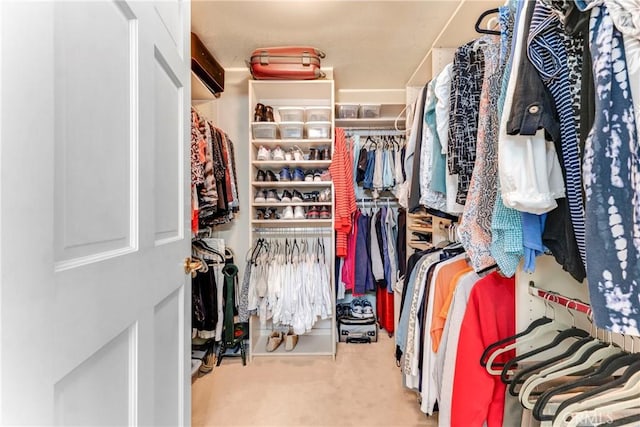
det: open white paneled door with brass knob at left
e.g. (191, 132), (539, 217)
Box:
(0, 0), (190, 426)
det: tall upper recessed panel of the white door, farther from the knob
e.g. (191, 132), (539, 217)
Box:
(53, 2), (138, 269)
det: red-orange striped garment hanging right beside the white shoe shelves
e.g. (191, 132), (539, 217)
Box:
(329, 128), (357, 258)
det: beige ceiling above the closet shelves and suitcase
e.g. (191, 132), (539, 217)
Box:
(191, 0), (498, 94)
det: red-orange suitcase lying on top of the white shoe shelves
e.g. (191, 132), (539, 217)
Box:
(249, 46), (325, 80)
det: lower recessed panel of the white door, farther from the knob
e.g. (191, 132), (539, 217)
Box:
(55, 329), (136, 426)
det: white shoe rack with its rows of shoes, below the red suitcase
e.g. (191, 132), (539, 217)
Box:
(248, 80), (336, 360)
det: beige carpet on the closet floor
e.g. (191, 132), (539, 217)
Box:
(192, 331), (438, 427)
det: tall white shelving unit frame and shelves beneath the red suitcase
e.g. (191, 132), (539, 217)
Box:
(248, 80), (336, 360)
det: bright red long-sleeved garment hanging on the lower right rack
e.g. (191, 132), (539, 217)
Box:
(451, 272), (516, 427)
